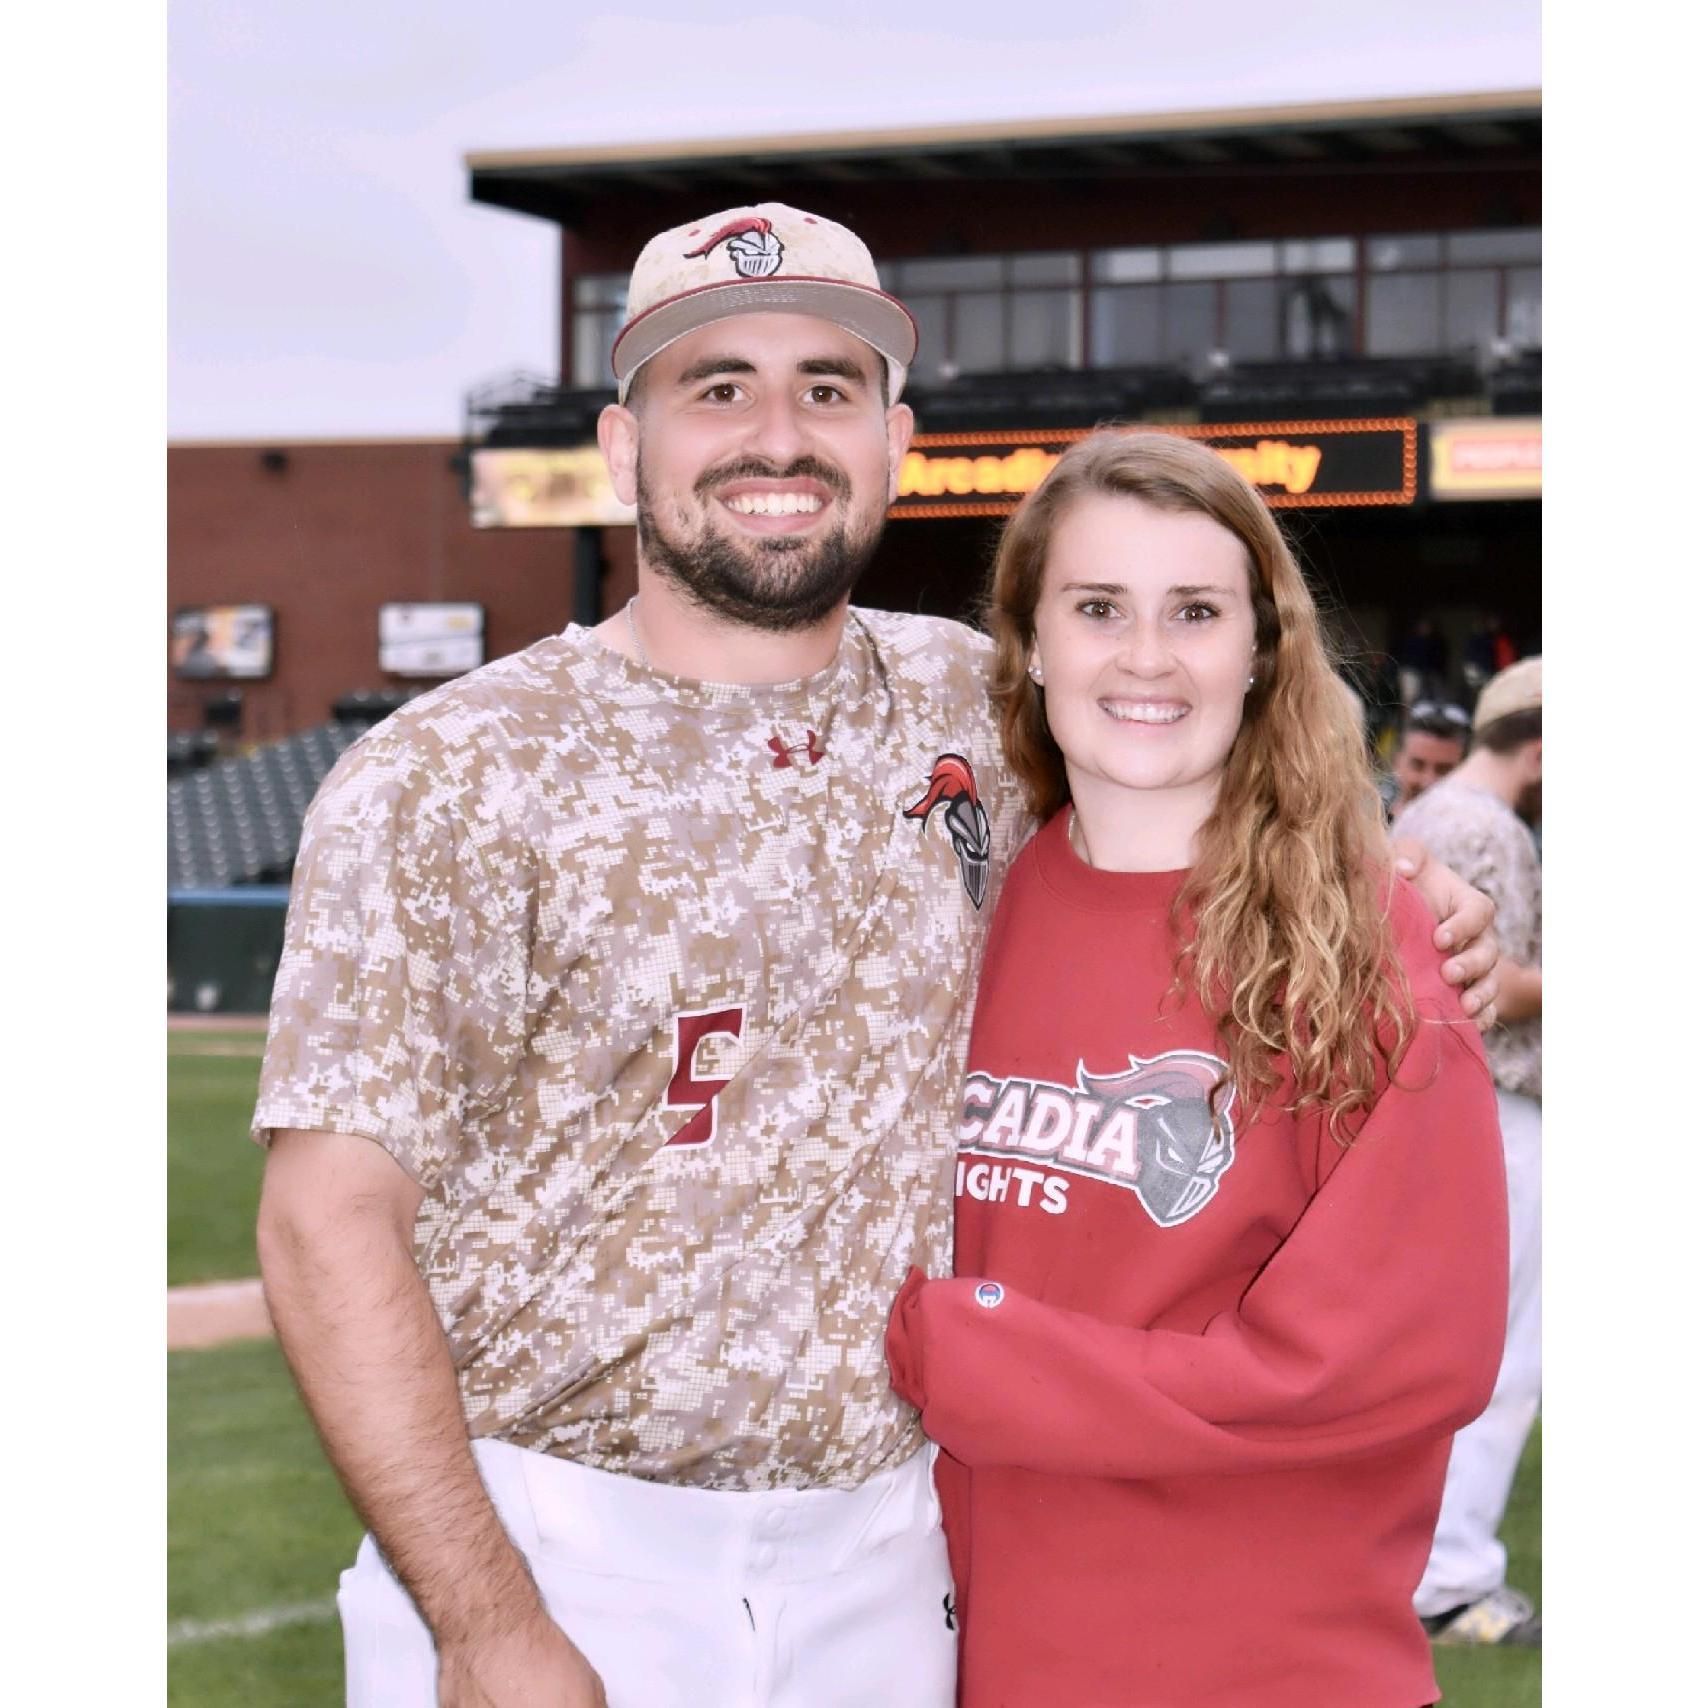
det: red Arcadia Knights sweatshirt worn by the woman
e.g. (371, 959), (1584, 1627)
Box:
(888, 815), (1506, 1708)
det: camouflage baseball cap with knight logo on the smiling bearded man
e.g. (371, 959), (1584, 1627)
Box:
(611, 202), (919, 403)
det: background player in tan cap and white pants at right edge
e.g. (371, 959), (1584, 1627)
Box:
(1394, 658), (1542, 1647)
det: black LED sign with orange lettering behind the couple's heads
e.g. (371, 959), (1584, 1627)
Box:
(890, 417), (1418, 516)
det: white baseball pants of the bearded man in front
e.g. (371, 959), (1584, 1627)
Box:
(338, 1442), (955, 1708)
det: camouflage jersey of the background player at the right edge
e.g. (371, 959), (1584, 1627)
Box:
(1394, 777), (1542, 1097)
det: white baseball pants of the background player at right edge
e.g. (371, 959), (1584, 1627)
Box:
(1413, 1090), (1542, 1619)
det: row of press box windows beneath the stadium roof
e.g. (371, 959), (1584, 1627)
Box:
(574, 227), (1542, 386)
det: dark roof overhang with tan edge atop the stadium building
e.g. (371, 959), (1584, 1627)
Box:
(465, 89), (1542, 229)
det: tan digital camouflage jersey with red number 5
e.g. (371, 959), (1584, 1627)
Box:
(254, 611), (1027, 1488)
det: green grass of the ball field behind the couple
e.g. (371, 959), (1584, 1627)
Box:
(167, 1032), (1542, 1708)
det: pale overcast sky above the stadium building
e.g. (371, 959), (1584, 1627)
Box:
(167, 0), (1542, 439)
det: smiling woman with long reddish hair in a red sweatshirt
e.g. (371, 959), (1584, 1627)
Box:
(890, 432), (1506, 1708)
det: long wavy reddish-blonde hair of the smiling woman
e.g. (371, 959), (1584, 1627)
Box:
(986, 430), (1416, 1143)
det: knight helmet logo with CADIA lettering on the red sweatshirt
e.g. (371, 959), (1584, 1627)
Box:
(960, 1050), (1233, 1228)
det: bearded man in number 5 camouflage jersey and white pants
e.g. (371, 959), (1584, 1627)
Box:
(254, 205), (1493, 1708)
